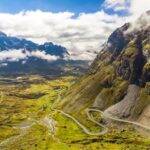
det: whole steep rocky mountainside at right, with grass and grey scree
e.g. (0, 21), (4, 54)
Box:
(60, 11), (150, 124)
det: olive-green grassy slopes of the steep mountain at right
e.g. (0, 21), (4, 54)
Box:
(60, 40), (150, 120)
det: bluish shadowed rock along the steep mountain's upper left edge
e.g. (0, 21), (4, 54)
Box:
(90, 23), (130, 72)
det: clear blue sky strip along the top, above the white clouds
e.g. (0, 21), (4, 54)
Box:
(0, 0), (104, 13)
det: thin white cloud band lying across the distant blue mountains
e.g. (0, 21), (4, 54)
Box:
(0, 49), (59, 63)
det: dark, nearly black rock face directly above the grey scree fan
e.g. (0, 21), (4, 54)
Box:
(117, 34), (146, 85)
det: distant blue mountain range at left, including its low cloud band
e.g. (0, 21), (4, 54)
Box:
(0, 32), (88, 76)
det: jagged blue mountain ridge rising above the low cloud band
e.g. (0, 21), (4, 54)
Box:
(0, 32), (69, 58)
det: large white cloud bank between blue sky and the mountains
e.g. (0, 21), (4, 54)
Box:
(0, 0), (150, 60)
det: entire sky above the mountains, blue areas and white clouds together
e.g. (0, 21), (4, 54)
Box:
(0, 0), (150, 60)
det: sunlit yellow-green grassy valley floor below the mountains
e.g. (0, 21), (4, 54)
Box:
(0, 76), (150, 150)
